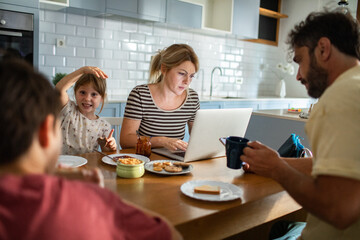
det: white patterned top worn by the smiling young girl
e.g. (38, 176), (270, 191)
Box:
(60, 100), (111, 155)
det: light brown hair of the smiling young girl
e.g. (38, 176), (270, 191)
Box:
(74, 73), (106, 113)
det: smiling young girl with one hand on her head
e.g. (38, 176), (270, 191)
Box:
(56, 66), (116, 155)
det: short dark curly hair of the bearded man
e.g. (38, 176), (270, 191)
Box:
(287, 11), (360, 59)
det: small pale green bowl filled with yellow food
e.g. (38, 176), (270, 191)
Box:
(116, 157), (145, 178)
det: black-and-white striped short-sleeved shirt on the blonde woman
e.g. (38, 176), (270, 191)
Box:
(124, 84), (200, 139)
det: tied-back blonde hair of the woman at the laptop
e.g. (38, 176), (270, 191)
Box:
(149, 44), (199, 83)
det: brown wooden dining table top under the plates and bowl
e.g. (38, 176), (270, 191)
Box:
(81, 149), (301, 239)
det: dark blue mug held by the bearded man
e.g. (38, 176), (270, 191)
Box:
(220, 136), (249, 169)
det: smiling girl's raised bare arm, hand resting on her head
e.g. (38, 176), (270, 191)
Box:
(55, 66), (108, 106)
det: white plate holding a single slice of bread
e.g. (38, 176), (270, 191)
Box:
(180, 180), (243, 202)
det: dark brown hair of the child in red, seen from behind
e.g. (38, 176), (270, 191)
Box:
(0, 60), (61, 165)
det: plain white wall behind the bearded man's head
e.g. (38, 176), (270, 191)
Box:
(279, 0), (357, 97)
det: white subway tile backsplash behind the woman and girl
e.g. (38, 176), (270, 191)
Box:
(39, 10), (280, 100)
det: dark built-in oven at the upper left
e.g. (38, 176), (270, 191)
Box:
(0, 9), (34, 64)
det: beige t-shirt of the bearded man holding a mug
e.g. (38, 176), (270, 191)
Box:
(301, 64), (360, 240)
